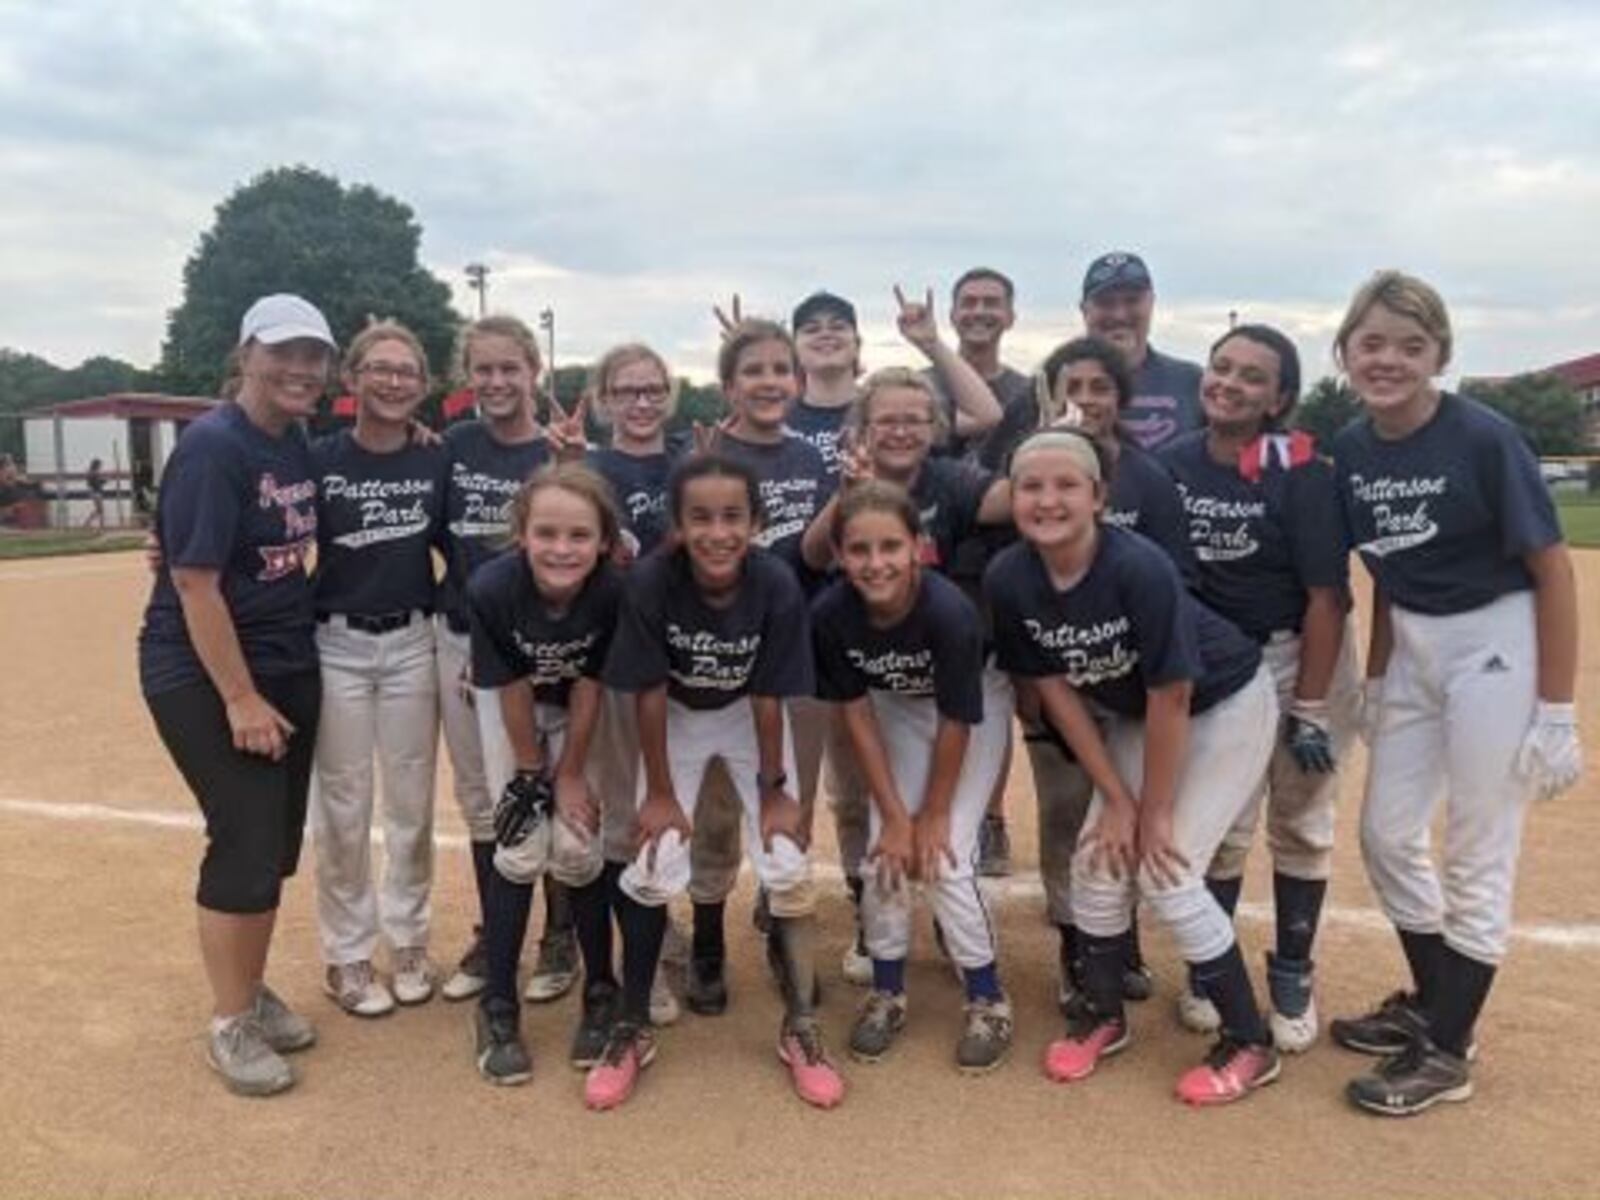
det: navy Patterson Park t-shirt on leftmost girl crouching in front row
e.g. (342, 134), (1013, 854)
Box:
(467, 549), (622, 709)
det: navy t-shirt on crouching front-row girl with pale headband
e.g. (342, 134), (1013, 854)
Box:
(984, 528), (1261, 717)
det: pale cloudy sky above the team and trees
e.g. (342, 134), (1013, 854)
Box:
(0, 0), (1600, 385)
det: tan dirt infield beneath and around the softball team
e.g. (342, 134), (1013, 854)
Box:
(0, 552), (1600, 1200)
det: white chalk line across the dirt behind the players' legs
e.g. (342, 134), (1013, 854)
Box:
(12, 797), (1600, 950)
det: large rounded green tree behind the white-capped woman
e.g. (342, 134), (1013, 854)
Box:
(162, 166), (461, 395)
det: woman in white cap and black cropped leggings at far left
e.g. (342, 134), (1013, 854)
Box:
(139, 294), (336, 1096)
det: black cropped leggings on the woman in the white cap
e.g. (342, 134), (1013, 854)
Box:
(146, 670), (322, 914)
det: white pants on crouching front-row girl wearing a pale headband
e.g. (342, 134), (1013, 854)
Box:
(1072, 664), (1278, 963)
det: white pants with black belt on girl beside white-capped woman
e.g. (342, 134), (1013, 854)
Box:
(310, 616), (438, 965)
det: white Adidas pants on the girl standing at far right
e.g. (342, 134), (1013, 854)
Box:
(1362, 592), (1539, 963)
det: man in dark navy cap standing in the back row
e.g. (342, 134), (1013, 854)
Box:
(1082, 251), (1203, 450)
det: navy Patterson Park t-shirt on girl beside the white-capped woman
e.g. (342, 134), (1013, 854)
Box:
(310, 429), (450, 616)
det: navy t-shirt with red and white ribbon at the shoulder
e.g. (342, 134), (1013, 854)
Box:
(1162, 432), (1350, 642)
